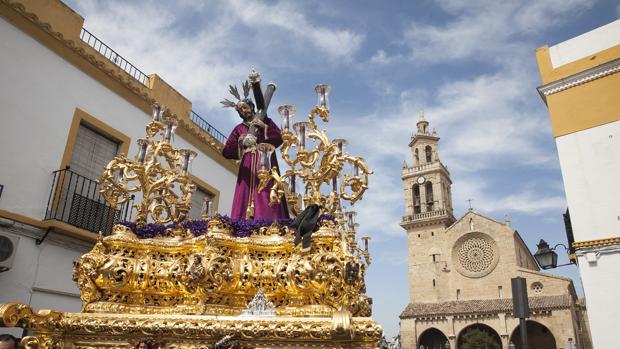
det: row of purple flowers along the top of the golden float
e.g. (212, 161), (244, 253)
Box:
(116, 214), (336, 239)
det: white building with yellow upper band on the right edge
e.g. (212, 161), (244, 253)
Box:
(536, 20), (620, 348)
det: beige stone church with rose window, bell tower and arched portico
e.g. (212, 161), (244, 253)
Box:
(400, 114), (590, 349)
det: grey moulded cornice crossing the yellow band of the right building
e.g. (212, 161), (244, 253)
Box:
(537, 58), (620, 104)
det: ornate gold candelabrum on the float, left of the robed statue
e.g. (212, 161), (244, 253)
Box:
(98, 104), (196, 227)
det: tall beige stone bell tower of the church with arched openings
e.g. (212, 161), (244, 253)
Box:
(400, 112), (455, 302)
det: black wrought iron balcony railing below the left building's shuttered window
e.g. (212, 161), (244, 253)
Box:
(45, 167), (133, 235)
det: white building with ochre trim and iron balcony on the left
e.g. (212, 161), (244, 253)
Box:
(0, 0), (237, 336)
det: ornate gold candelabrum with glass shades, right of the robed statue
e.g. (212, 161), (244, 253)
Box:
(258, 84), (373, 214)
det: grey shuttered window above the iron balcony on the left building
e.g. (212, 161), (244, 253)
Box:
(69, 124), (119, 179)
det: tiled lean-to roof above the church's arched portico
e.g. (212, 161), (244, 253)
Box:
(400, 295), (572, 319)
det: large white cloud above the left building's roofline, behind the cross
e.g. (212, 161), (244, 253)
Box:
(69, 0), (364, 118)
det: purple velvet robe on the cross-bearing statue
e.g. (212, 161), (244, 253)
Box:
(222, 117), (289, 220)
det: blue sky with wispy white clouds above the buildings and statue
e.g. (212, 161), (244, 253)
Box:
(67, 0), (620, 337)
